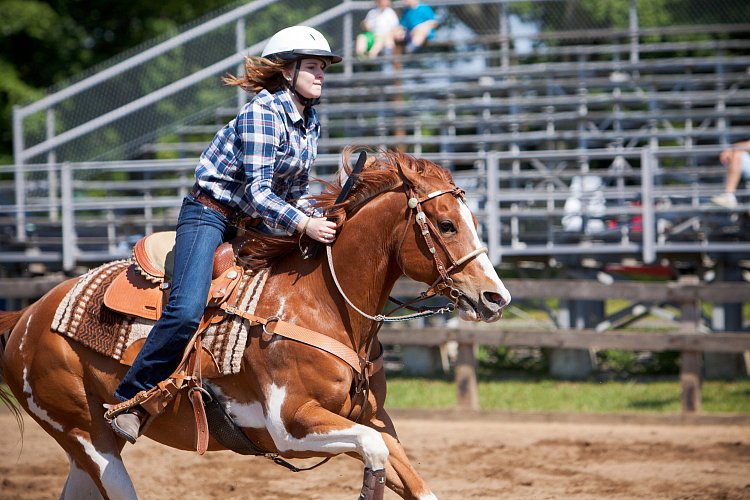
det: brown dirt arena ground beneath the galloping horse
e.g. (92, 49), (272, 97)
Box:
(0, 409), (750, 500)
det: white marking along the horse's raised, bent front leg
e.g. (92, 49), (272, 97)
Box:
(266, 385), (388, 470)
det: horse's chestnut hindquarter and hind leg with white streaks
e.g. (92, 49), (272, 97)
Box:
(5, 322), (136, 499)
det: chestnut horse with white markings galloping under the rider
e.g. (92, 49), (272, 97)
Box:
(0, 151), (510, 500)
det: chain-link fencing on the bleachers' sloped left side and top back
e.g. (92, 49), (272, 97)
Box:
(14, 0), (750, 163)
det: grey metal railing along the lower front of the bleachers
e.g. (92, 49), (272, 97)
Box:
(0, 147), (750, 271)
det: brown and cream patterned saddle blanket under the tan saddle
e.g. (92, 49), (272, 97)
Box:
(52, 259), (268, 375)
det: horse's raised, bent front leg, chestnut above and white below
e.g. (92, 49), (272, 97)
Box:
(268, 402), (389, 500)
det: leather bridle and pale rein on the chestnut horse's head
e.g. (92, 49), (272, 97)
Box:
(326, 178), (487, 323)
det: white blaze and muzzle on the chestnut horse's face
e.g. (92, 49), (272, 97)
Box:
(453, 199), (510, 322)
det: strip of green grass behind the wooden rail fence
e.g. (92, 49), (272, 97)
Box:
(386, 377), (750, 413)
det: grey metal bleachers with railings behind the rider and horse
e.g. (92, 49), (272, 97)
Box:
(0, 0), (750, 282)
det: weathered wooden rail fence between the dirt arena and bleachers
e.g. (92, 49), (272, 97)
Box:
(0, 276), (750, 414)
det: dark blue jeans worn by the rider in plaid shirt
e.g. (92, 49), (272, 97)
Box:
(115, 195), (234, 401)
